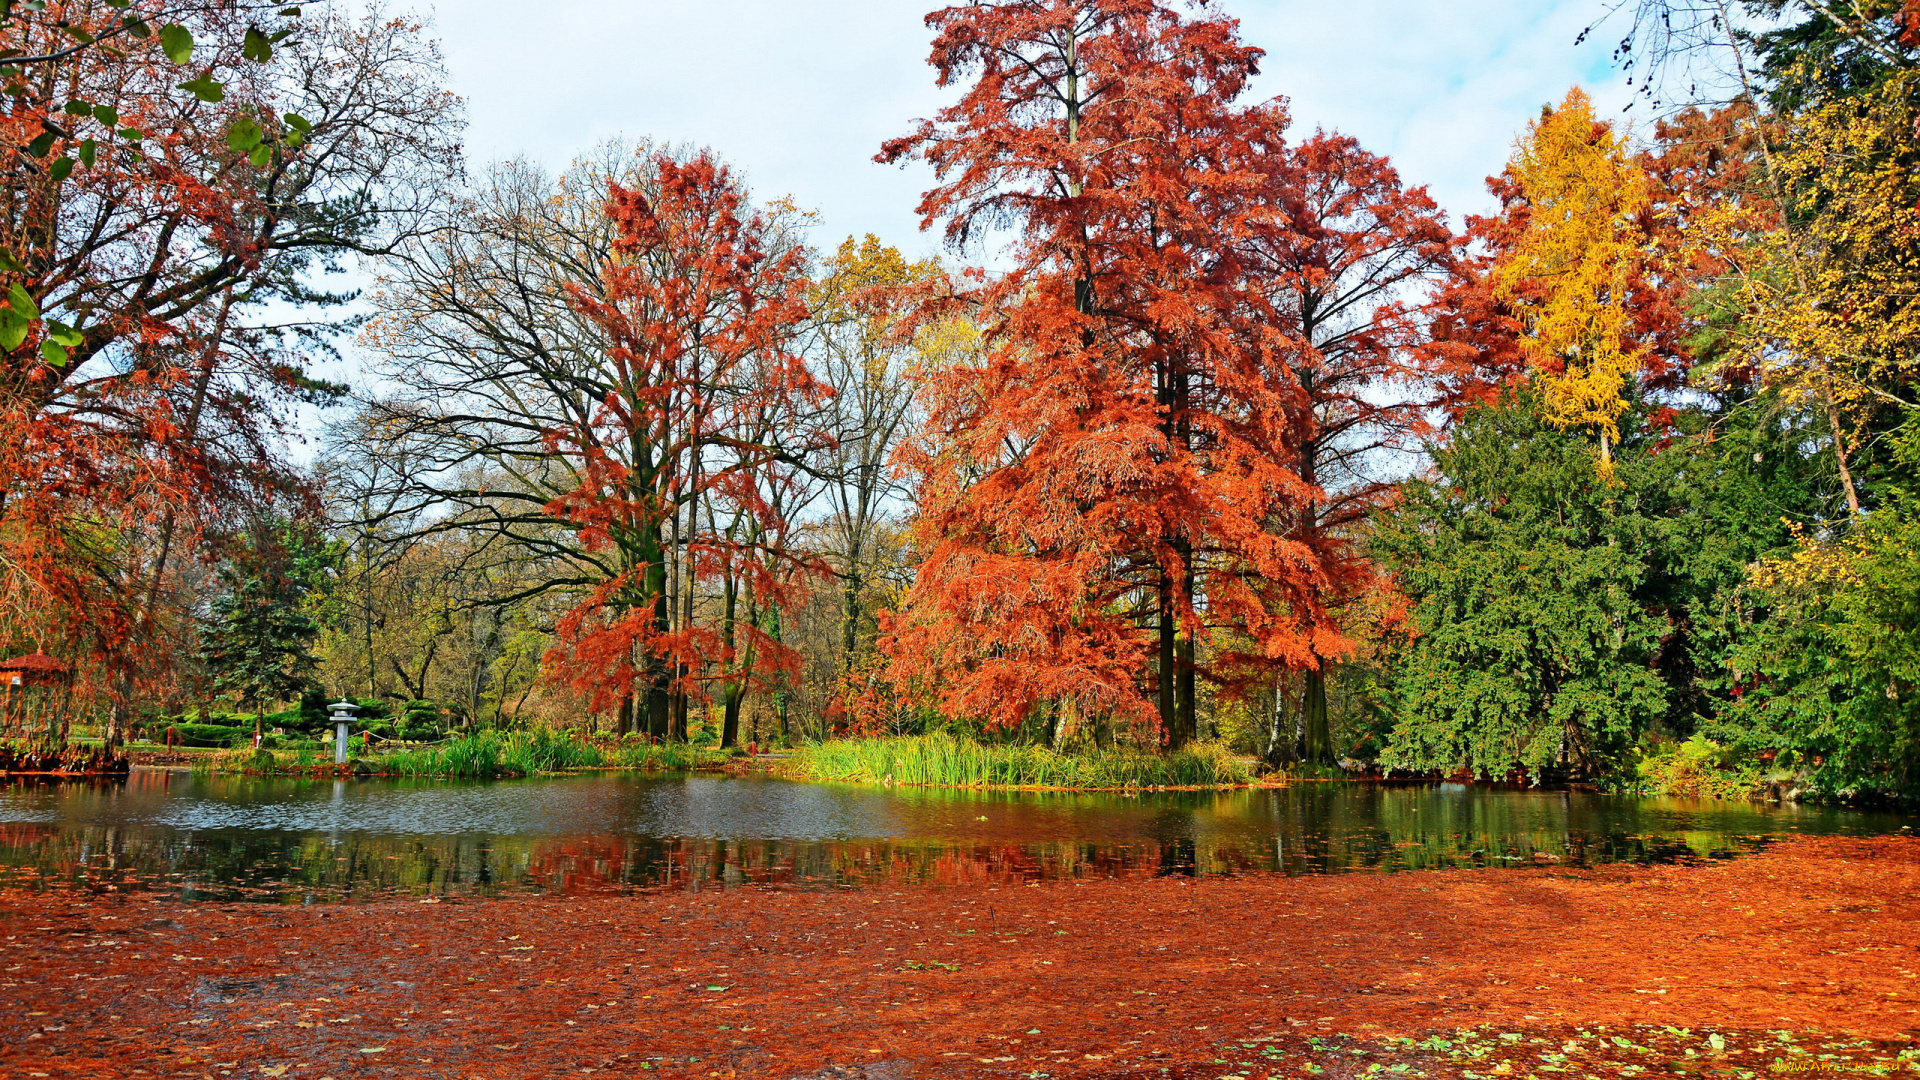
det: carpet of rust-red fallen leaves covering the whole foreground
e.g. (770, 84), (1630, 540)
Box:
(0, 826), (1920, 1080)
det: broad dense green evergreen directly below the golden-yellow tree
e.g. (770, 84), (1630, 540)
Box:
(1373, 392), (1824, 776)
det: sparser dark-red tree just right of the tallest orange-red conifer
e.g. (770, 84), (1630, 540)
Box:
(1221, 119), (1453, 765)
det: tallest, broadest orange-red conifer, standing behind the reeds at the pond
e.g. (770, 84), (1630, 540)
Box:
(881, 0), (1346, 746)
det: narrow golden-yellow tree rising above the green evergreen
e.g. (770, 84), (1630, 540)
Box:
(1494, 86), (1649, 475)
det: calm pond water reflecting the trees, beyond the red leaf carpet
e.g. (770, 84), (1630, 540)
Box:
(0, 771), (1907, 901)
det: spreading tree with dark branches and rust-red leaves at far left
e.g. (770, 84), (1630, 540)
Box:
(0, 2), (459, 740)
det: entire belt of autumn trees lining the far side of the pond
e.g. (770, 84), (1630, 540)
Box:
(0, 0), (1920, 796)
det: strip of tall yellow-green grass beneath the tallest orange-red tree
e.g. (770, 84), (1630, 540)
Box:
(781, 734), (1250, 790)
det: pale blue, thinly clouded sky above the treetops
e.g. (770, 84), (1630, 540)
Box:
(428, 0), (1628, 254)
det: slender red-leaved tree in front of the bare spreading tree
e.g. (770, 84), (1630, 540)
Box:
(545, 154), (828, 740)
